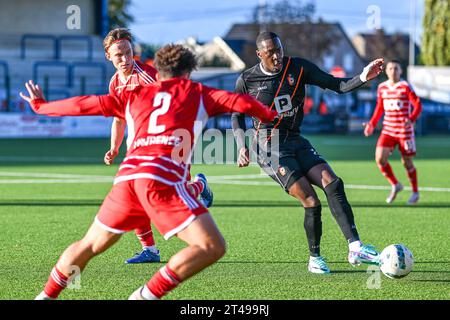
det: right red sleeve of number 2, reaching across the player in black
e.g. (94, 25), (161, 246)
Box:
(202, 86), (277, 122)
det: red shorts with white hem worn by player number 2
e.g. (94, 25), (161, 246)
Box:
(95, 179), (208, 240)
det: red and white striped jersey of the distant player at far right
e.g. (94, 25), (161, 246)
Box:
(370, 80), (422, 139)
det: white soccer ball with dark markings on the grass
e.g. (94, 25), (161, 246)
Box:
(380, 244), (414, 279)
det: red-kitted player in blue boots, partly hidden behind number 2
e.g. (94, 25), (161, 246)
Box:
(103, 28), (213, 263)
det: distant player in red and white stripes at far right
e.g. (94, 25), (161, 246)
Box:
(364, 60), (422, 204)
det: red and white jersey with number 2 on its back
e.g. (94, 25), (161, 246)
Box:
(31, 78), (277, 185)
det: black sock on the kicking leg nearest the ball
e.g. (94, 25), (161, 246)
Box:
(325, 178), (359, 243)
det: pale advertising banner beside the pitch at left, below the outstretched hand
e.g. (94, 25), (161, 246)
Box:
(0, 113), (112, 138)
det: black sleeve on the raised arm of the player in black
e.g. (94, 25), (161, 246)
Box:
(301, 59), (364, 93)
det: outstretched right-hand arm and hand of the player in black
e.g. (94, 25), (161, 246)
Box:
(305, 58), (384, 93)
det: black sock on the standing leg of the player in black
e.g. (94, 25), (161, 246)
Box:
(303, 205), (322, 257)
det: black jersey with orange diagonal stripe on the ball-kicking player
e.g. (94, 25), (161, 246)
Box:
(232, 57), (364, 133)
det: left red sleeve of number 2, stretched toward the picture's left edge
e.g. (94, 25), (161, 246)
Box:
(31, 95), (124, 118)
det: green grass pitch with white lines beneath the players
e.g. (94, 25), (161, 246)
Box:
(0, 136), (450, 300)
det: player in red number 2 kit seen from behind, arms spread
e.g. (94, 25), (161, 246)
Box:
(20, 45), (276, 300)
